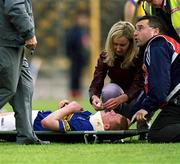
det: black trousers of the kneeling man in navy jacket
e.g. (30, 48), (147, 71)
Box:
(148, 105), (180, 143)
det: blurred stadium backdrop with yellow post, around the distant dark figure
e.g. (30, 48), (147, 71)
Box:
(31, 0), (125, 99)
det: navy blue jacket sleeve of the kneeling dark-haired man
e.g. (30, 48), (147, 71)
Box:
(142, 39), (171, 111)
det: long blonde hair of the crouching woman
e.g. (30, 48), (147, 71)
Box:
(104, 21), (138, 69)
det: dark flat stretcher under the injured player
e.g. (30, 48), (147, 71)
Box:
(0, 129), (148, 144)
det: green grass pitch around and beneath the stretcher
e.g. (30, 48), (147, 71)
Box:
(0, 100), (180, 164)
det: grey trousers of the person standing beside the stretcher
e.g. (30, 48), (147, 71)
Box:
(0, 46), (38, 144)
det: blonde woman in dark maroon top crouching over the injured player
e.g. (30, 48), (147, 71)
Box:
(89, 21), (146, 131)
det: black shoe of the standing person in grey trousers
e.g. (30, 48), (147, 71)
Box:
(16, 139), (50, 145)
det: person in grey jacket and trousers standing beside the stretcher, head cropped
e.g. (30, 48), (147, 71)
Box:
(0, 0), (49, 144)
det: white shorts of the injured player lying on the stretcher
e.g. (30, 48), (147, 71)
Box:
(0, 110), (39, 131)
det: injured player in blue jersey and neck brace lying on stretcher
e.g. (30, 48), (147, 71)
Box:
(0, 100), (128, 132)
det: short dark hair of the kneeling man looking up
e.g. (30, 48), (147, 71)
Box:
(136, 15), (167, 34)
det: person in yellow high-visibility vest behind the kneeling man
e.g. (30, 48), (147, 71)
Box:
(143, 0), (180, 43)
